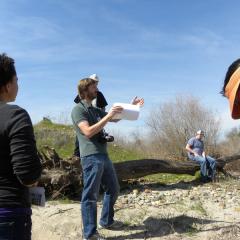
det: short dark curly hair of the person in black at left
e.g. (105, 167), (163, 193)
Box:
(0, 53), (16, 88)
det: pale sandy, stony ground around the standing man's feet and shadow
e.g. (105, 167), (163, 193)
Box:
(32, 179), (240, 240)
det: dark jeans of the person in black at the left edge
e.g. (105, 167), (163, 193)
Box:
(0, 215), (32, 240)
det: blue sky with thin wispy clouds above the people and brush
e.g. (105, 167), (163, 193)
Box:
(0, 0), (240, 135)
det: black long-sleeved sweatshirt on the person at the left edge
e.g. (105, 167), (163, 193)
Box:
(0, 102), (42, 208)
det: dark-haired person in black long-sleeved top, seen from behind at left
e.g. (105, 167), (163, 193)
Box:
(0, 54), (42, 240)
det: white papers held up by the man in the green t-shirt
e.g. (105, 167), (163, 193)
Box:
(113, 103), (140, 121)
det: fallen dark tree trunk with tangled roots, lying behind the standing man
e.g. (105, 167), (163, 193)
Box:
(39, 146), (240, 199)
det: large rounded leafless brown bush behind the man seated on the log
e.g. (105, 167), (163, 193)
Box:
(146, 95), (220, 160)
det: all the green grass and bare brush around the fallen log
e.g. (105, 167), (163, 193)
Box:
(34, 96), (240, 182)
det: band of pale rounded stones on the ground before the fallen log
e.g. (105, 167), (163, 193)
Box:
(117, 182), (240, 208)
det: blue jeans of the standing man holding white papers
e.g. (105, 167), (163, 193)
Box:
(81, 154), (120, 238)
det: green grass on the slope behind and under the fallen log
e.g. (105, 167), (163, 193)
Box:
(34, 120), (198, 184)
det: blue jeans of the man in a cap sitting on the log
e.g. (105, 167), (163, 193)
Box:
(192, 156), (216, 179)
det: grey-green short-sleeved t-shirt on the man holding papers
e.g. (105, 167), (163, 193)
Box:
(72, 100), (107, 157)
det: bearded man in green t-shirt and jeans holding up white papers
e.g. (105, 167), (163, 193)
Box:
(72, 78), (144, 239)
